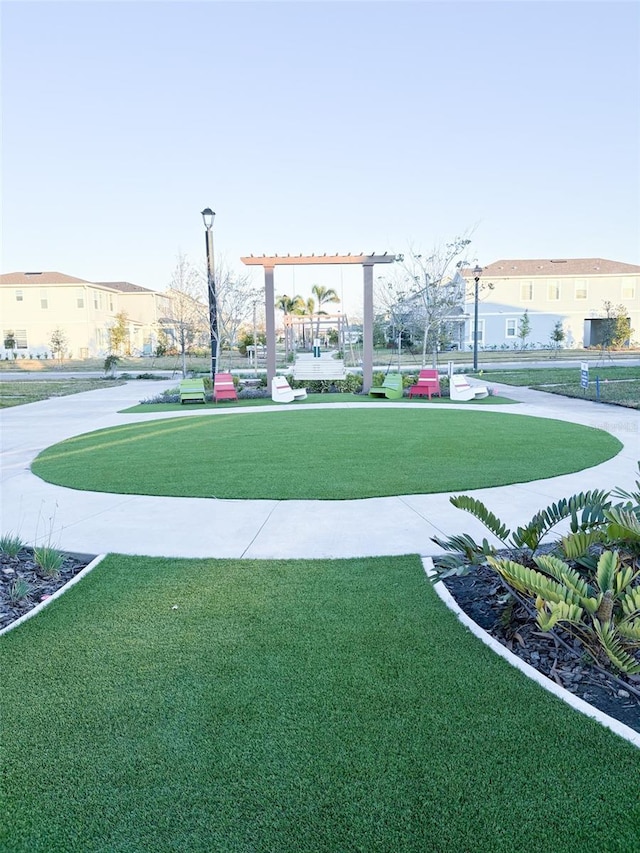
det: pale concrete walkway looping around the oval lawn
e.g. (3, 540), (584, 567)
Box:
(0, 380), (640, 559)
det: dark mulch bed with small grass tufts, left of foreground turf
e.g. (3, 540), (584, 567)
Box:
(0, 548), (95, 629)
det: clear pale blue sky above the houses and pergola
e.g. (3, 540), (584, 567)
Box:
(0, 0), (640, 316)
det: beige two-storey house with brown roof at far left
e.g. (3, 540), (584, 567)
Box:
(0, 272), (171, 358)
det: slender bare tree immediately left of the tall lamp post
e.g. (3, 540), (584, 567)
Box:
(160, 253), (209, 376)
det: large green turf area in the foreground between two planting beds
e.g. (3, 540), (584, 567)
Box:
(0, 556), (640, 853)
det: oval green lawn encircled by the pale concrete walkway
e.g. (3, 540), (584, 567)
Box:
(32, 405), (622, 500)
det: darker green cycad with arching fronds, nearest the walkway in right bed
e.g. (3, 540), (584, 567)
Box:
(432, 490), (611, 578)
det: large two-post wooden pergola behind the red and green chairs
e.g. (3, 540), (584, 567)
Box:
(240, 252), (397, 392)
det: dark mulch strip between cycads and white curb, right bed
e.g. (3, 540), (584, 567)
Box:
(443, 566), (640, 732)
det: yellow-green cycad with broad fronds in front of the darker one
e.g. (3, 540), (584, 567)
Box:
(487, 550), (640, 675)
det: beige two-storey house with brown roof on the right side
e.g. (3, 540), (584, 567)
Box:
(462, 258), (640, 349)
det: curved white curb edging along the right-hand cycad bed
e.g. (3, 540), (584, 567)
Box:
(422, 557), (640, 748)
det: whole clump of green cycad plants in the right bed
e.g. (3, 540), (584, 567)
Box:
(433, 463), (640, 675)
